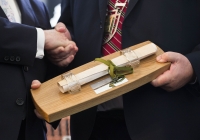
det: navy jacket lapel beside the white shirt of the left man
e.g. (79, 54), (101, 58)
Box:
(17, 0), (35, 26)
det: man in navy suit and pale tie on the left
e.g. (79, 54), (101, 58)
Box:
(0, 0), (77, 140)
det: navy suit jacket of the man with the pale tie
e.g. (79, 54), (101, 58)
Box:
(0, 0), (50, 140)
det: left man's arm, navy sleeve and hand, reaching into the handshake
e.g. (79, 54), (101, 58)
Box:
(0, 17), (76, 66)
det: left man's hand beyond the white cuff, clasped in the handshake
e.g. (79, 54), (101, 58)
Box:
(44, 25), (78, 66)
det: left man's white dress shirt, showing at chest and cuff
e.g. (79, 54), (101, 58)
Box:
(0, 0), (45, 59)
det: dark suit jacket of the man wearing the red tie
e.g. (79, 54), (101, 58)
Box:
(59, 0), (200, 140)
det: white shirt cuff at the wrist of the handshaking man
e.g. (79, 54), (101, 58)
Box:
(35, 28), (45, 59)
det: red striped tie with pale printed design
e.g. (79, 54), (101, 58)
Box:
(102, 0), (128, 55)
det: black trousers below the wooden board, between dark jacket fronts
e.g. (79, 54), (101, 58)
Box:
(89, 110), (131, 140)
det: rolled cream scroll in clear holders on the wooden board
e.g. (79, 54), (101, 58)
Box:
(57, 43), (157, 93)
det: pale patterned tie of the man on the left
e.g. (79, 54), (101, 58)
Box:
(0, 0), (16, 22)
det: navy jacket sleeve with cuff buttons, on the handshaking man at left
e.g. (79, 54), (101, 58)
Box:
(0, 17), (37, 66)
